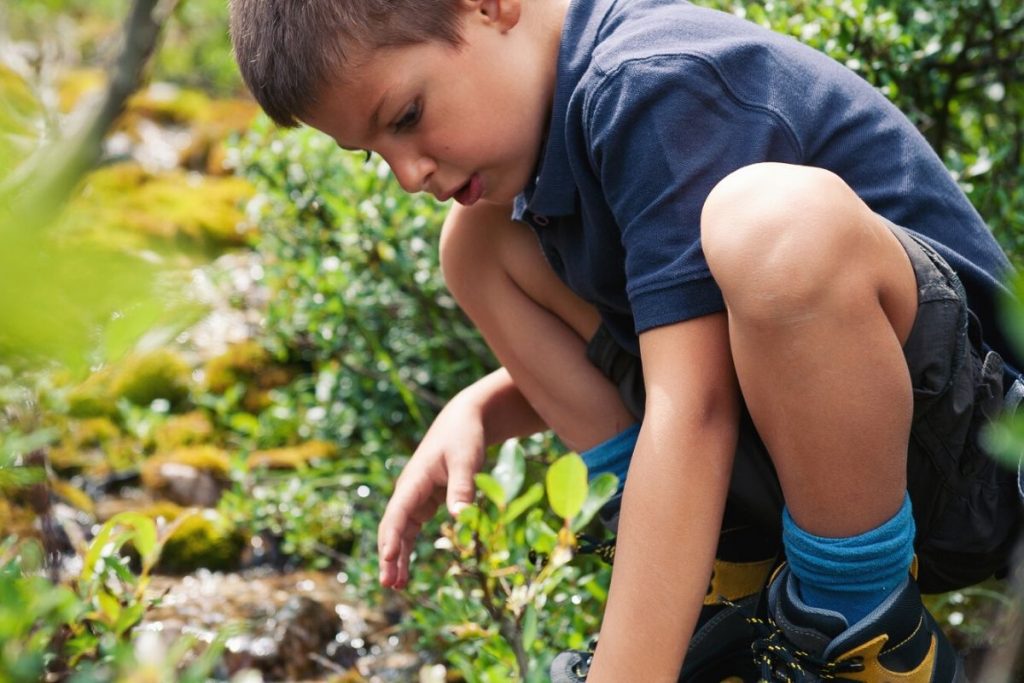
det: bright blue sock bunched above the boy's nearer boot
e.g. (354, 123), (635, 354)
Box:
(782, 496), (914, 626)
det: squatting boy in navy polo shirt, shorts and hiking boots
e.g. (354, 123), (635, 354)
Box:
(231, 0), (1019, 683)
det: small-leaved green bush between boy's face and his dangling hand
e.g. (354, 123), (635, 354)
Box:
(238, 118), (494, 457)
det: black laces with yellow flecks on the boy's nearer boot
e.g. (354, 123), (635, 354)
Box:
(746, 616), (864, 683)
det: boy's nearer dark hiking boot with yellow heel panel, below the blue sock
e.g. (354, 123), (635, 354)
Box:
(754, 566), (967, 683)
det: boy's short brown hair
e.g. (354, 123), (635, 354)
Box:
(230, 0), (462, 128)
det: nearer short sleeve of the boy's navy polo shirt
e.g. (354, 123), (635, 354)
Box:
(585, 55), (801, 334)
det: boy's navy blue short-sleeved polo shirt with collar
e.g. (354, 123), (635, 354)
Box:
(514, 0), (1009, 362)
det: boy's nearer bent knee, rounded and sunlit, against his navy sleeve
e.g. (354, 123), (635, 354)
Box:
(700, 163), (877, 316)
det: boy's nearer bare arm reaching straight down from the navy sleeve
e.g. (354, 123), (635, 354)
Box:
(587, 313), (739, 683)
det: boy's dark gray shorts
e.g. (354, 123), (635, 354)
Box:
(587, 223), (1022, 593)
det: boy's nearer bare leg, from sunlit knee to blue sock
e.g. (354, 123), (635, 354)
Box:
(701, 164), (918, 537)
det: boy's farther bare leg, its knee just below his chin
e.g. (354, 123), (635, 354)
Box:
(441, 200), (635, 451)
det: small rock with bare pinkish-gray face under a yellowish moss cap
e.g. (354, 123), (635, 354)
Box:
(140, 445), (230, 506)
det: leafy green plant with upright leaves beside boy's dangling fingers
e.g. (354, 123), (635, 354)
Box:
(409, 441), (616, 683)
